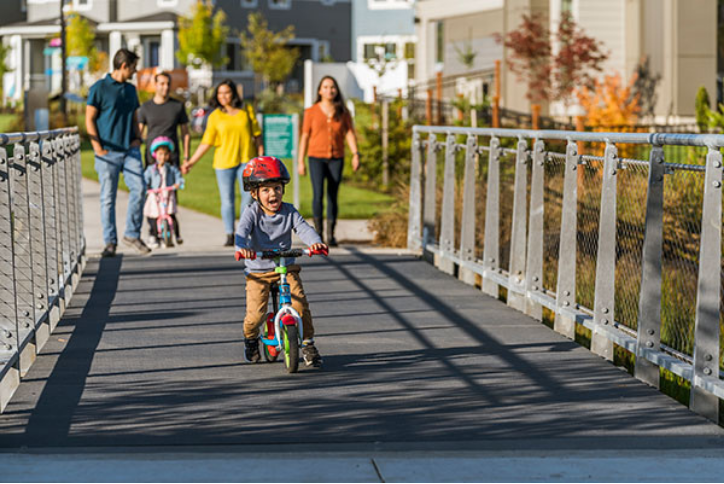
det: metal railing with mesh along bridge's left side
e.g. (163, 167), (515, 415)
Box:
(0, 128), (85, 411)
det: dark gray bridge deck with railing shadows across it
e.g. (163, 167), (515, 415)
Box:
(0, 250), (724, 450)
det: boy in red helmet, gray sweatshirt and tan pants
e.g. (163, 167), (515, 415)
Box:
(235, 156), (327, 367)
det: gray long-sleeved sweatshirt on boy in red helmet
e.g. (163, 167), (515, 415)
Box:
(235, 203), (322, 274)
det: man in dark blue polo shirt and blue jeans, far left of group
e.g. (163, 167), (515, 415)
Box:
(85, 49), (151, 257)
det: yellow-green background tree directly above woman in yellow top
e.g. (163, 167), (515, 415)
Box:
(176, 0), (229, 69)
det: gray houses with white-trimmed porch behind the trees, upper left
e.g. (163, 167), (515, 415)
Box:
(0, 0), (352, 100)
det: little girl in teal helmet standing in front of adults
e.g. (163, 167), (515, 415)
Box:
(143, 136), (184, 249)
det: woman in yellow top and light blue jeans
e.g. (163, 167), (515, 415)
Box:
(181, 79), (264, 246)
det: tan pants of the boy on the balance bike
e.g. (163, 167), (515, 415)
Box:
(244, 264), (314, 340)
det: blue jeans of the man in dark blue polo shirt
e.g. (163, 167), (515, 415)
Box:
(95, 148), (146, 244)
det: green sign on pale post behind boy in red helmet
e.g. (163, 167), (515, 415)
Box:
(262, 114), (299, 210)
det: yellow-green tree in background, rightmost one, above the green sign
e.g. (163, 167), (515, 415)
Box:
(241, 12), (299, 86)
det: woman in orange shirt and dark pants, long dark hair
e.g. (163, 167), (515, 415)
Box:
(297, 76), (359, 247)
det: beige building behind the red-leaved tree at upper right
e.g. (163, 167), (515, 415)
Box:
(416, 0), (717, 118)
